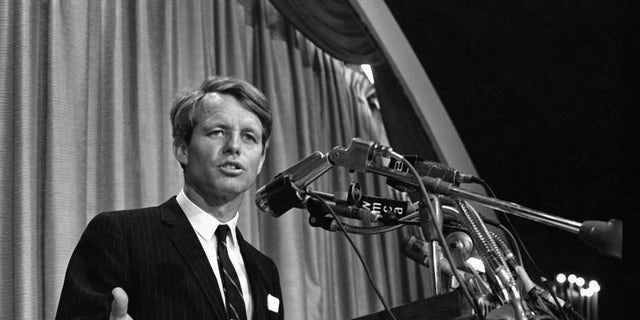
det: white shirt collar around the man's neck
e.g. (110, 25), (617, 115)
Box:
(176, 188), (238, 244)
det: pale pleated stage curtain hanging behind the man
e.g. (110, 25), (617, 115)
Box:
(0, 0), (432, 319)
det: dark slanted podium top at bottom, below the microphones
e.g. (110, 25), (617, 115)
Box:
(353, 290), (474, 320)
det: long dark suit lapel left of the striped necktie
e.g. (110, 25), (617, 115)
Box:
(160, 197), (227, 319)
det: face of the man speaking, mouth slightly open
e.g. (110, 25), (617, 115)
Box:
(174, 93), (265, 204)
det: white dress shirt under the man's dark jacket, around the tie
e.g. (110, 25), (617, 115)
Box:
(176, 189), (253, 319)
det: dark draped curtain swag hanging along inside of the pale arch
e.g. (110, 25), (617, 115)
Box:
(271, 0), (439, 161)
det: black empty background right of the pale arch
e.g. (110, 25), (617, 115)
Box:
(385, 0), (640, 319)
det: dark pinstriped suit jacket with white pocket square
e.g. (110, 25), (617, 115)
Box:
(56, 197), (284, 320)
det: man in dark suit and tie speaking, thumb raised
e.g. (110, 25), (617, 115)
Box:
(56, 77), (284, 320)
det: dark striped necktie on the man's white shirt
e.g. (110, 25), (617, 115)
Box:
(216, 224), (247, 320)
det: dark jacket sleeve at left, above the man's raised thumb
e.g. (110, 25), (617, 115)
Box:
(56, 212), (129, 320)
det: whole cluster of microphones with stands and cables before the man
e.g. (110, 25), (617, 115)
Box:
(256, 138), (622, 320)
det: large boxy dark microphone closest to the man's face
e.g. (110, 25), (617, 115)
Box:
(255, 151), (331, 218)
